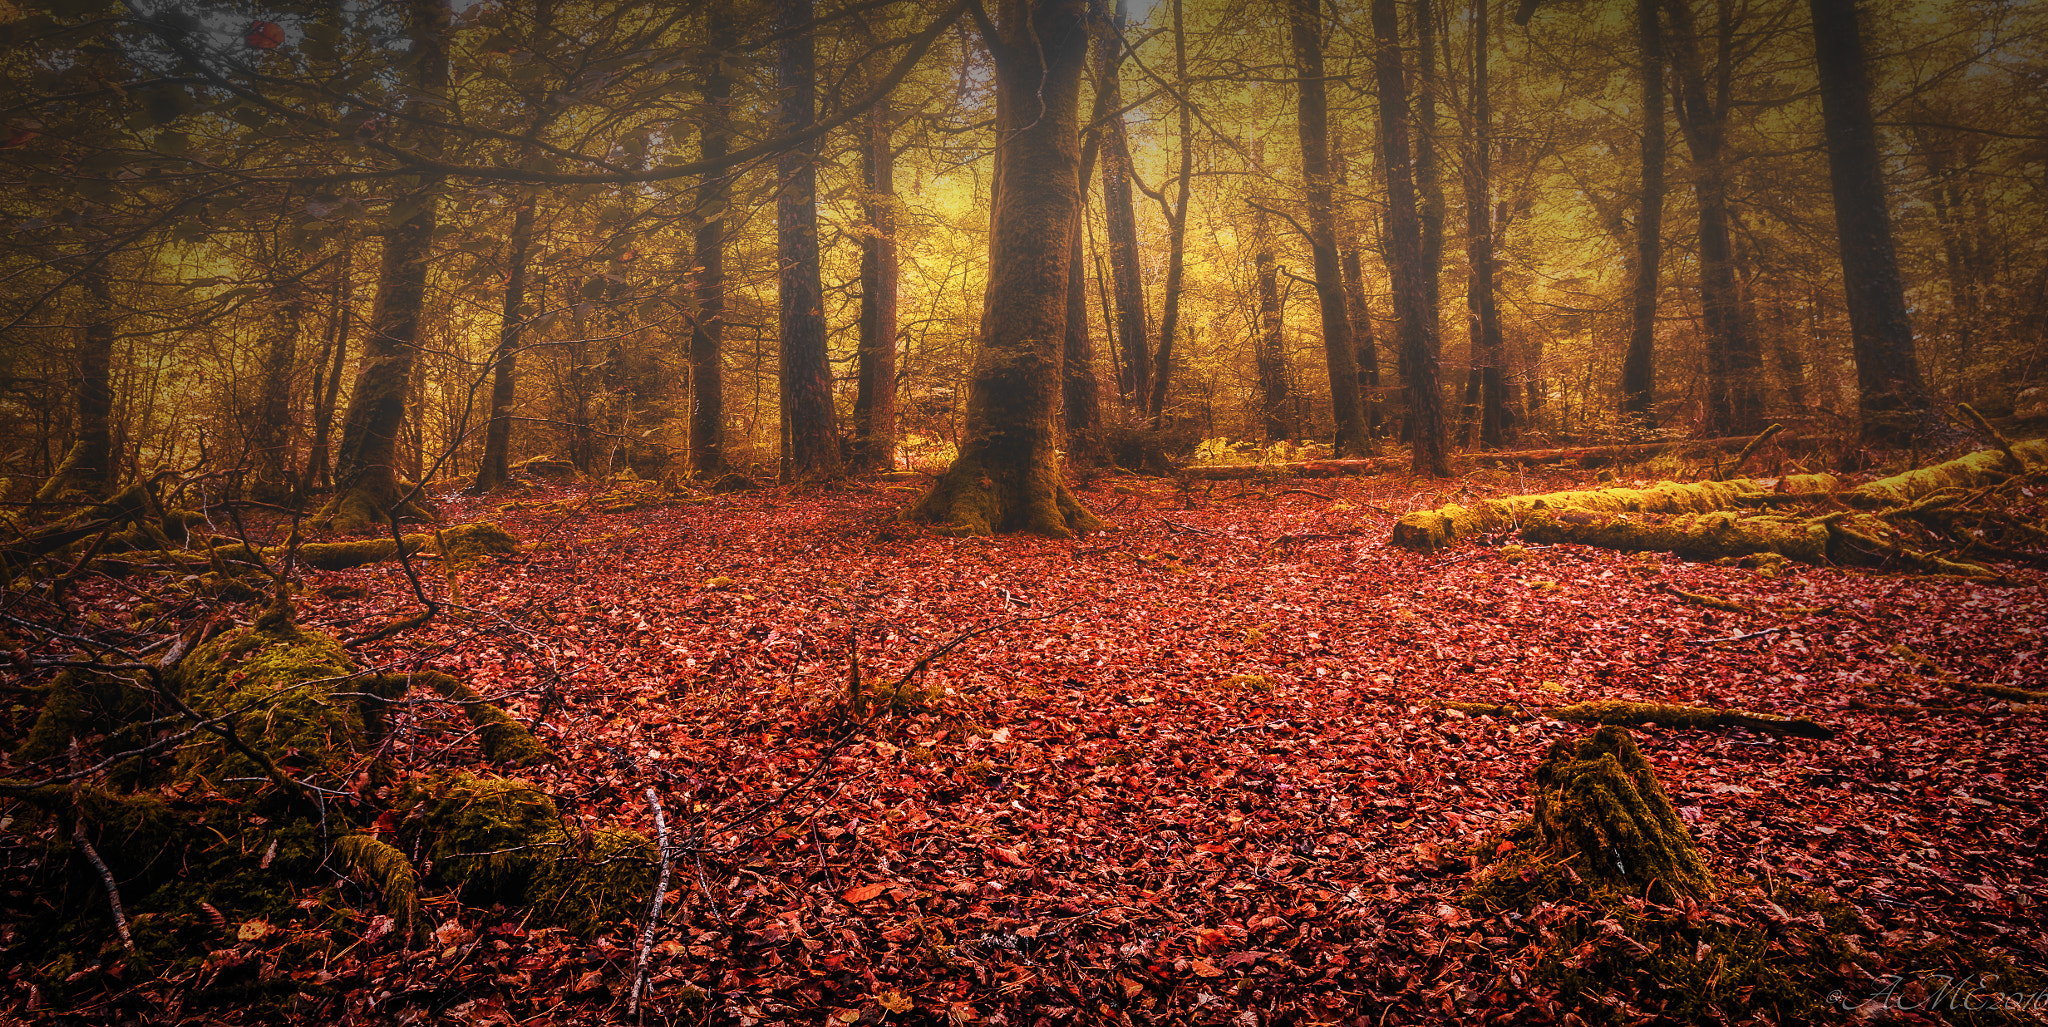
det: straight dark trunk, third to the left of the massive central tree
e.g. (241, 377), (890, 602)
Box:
(690, 4), (733, 478)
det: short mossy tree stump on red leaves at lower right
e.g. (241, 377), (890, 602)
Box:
(1466, 726), (1714, 908)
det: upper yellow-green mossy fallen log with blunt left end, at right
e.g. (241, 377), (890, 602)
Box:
(1391, 476), (1835, 553)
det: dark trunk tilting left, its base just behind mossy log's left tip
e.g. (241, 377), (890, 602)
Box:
(1372, 0), (1450, 478)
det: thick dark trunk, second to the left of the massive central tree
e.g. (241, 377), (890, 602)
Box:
(776, 0), (842, 482)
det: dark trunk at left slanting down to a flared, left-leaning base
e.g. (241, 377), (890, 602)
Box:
(322, 0), (449, 531)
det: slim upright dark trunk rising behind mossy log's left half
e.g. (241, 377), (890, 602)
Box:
(1464, 0), (1507, 449)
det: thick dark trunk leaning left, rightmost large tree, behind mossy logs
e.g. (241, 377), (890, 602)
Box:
(1808, 0), (1946, 443)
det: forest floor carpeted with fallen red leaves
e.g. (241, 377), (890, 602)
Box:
(32, 474), (2048, 1027)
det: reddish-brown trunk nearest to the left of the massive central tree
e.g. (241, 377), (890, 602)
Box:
(854, 100), (897, 471)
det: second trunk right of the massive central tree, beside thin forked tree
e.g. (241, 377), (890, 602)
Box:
(1096, 0), (1151, 408)
